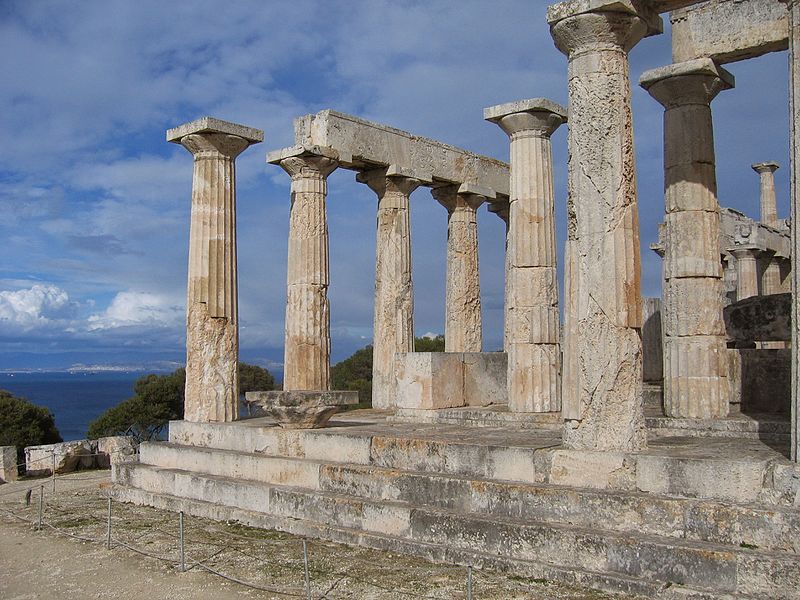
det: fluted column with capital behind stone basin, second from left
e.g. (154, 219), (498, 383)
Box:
(268, 147), (338, 391)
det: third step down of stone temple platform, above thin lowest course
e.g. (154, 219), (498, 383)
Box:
(116, 464), (800, 597)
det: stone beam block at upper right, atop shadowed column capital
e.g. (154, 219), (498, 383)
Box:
(670, 0), (789, 64)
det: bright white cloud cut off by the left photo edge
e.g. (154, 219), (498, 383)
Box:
(0, 284), (70, 330)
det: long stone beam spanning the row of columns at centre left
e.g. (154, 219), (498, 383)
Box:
(290, 110), (509, 198)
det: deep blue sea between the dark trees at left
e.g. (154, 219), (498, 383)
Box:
(0, 372), (145, 441)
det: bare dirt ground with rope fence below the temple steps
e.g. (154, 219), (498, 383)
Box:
(0, 471), (633, 600)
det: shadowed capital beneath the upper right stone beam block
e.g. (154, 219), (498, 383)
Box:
(639, 58), (736, 109)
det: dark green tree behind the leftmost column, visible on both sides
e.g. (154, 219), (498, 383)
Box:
(88, 362), (275, 442)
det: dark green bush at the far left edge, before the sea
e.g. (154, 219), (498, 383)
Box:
(0, 390), (63, 463)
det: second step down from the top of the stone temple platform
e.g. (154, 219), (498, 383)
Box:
(140, 443), (800, 552)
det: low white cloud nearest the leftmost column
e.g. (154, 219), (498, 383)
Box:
(88, 291), (184, 331)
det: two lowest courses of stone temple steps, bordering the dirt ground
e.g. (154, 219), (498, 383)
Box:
(114, 463), (800, 598)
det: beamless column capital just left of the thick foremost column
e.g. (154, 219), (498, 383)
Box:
(483, 98), (567, 140)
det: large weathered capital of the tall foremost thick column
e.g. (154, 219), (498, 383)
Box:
(547, 0), (663, 56)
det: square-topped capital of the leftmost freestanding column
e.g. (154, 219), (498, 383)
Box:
(167, 117), (264, 160)
